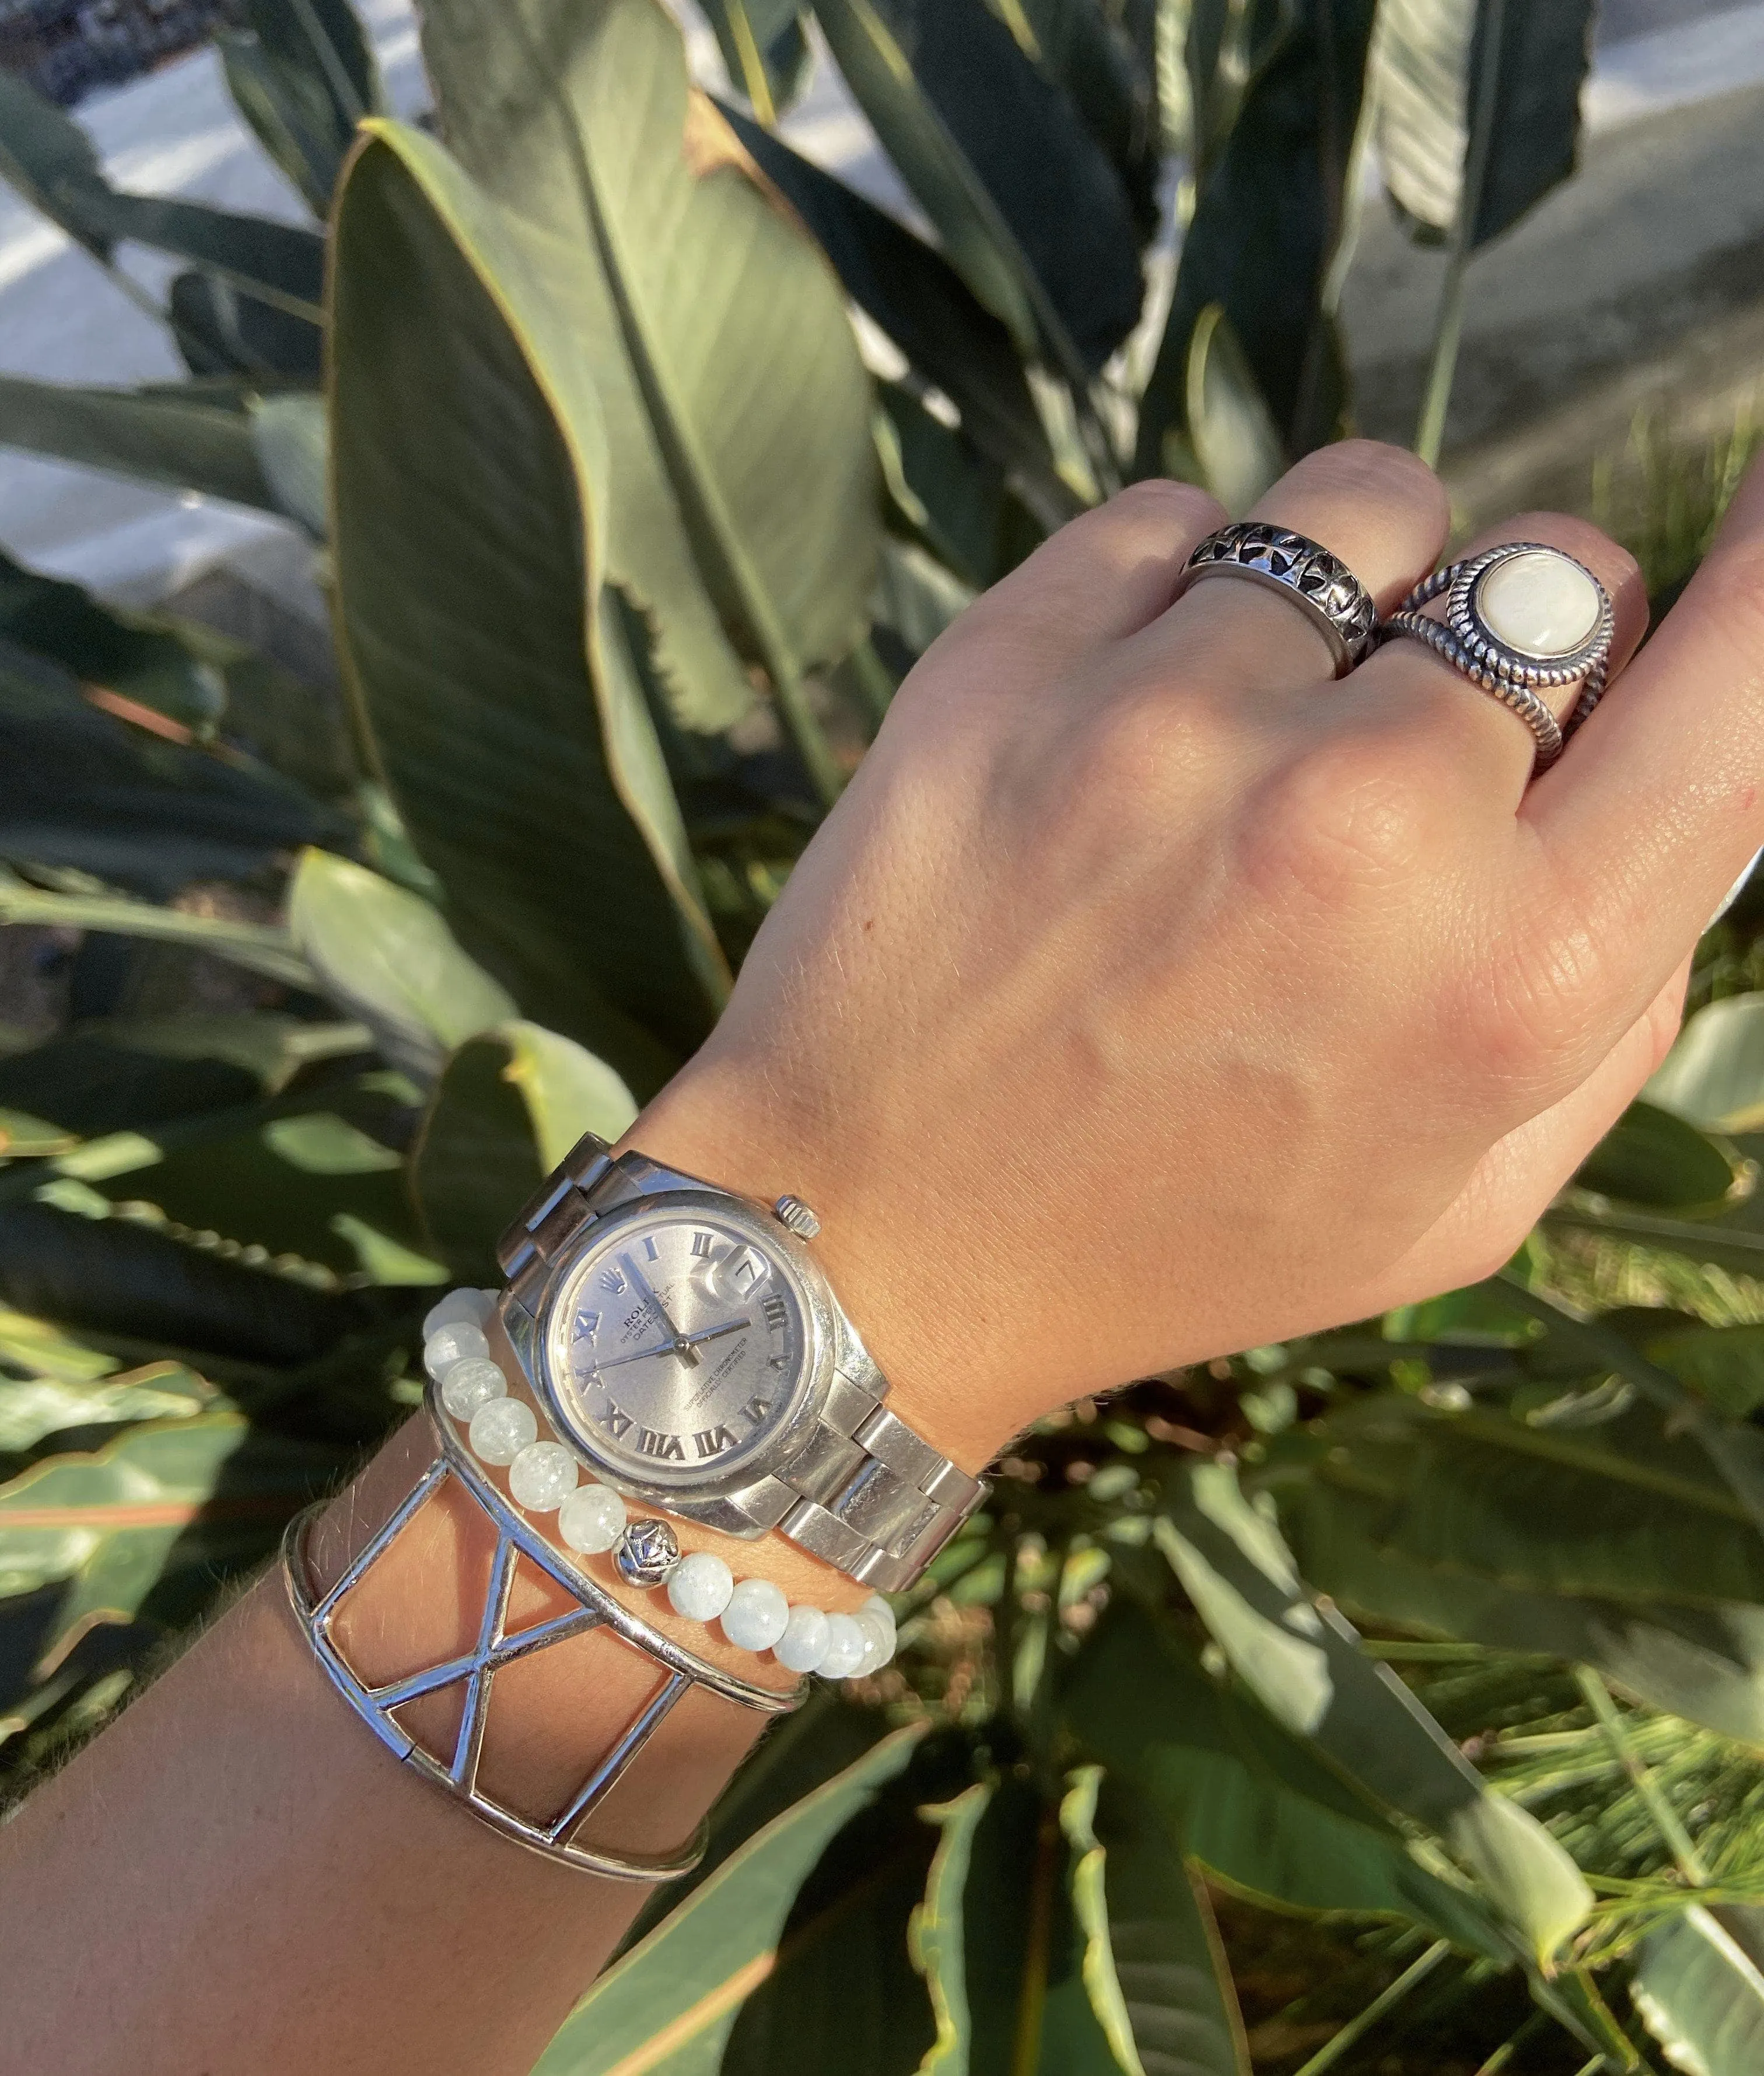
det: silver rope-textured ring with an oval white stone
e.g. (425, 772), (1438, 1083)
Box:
(1378, 540), (1616, 770)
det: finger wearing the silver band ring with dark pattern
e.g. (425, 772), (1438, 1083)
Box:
(1143, 440), (1451, 694)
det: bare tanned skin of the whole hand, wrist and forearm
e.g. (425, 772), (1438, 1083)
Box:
(0, 442), (1764, 2076)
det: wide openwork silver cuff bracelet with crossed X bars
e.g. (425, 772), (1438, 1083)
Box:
(282, 1387), (807, 1881)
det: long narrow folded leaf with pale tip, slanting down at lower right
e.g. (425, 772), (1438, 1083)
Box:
(1156, 1464), (1592, 1962)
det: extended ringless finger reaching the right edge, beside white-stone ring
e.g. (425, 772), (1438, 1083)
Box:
(1521, 450), (1764, 967)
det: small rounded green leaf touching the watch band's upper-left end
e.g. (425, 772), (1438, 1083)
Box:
(411, 1024), (637, 1283)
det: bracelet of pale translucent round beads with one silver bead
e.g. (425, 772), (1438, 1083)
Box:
(424, 1289), (897, 1679)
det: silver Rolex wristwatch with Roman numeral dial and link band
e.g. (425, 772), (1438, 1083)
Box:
(498, 1136), (988, 1592)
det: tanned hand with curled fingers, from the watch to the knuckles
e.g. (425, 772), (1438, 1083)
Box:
(631, 442), (1764, 1466)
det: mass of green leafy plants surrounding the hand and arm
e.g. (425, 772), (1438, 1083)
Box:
(0, 0), (1764, 2076)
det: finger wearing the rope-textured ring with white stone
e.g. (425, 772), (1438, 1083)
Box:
(1343, 513), (1648, 816)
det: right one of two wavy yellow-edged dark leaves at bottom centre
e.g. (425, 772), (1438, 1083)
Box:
(1060, 1767), (1250, 2076)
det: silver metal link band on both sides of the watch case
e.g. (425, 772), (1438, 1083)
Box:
(496, 1133), (990, 1592)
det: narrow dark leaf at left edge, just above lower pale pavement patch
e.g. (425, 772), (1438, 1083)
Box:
(0, 376), (282, 513)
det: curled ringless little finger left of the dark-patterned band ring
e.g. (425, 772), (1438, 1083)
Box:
(957, 482), (1224, 666)
